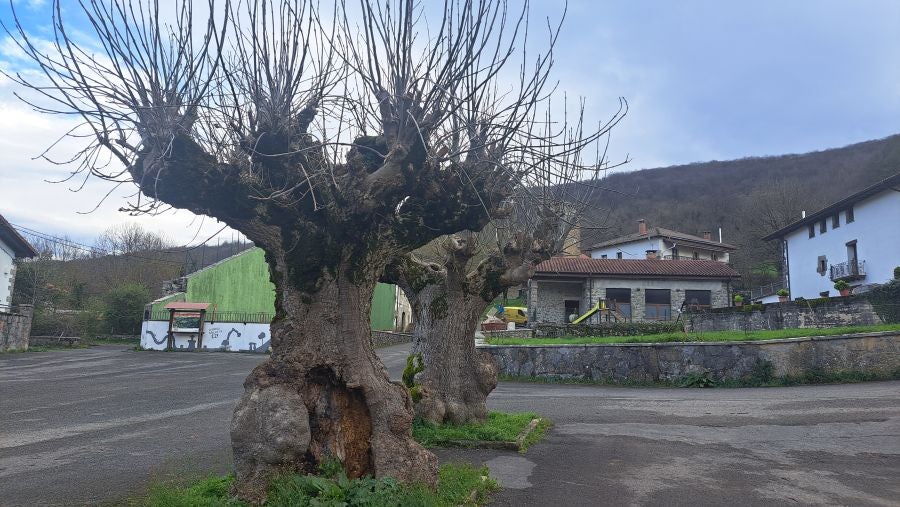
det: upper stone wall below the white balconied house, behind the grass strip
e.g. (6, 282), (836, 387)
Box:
(683, 297), (882, 332)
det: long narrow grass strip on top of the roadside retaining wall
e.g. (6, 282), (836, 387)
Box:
(487, 324), (900, 345)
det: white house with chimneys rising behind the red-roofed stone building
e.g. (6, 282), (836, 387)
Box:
(587, 220), (737, 263)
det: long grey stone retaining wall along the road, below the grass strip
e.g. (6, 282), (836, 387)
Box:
(478, 331), (900, 382)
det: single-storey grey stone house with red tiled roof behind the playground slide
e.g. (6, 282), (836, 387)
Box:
(528, 256), (740, 324)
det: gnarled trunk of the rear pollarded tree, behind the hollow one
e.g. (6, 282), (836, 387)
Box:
(385, 233), (550, 424)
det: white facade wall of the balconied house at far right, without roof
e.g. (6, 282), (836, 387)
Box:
(785, 190), (900, 299)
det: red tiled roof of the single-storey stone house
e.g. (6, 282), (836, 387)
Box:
(534, 257), (741, 279)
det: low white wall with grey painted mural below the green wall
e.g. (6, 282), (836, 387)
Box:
(141, 320), (271, 353)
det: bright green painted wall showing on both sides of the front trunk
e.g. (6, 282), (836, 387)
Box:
(153, 248), (396, 330)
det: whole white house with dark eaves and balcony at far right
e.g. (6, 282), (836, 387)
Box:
(763, 173), (900, 299)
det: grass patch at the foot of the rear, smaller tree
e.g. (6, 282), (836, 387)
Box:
(413, 412), (551, 452)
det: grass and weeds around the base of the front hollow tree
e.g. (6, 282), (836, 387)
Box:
(144, 463), (500, 507)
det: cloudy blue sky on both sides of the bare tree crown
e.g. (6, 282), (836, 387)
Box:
(0, 0), (900, 243)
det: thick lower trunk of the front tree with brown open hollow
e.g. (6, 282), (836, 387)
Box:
(231, 263), (437, 502)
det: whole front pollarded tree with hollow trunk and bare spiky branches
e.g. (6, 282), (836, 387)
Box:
(9, 0), (612, 501)
